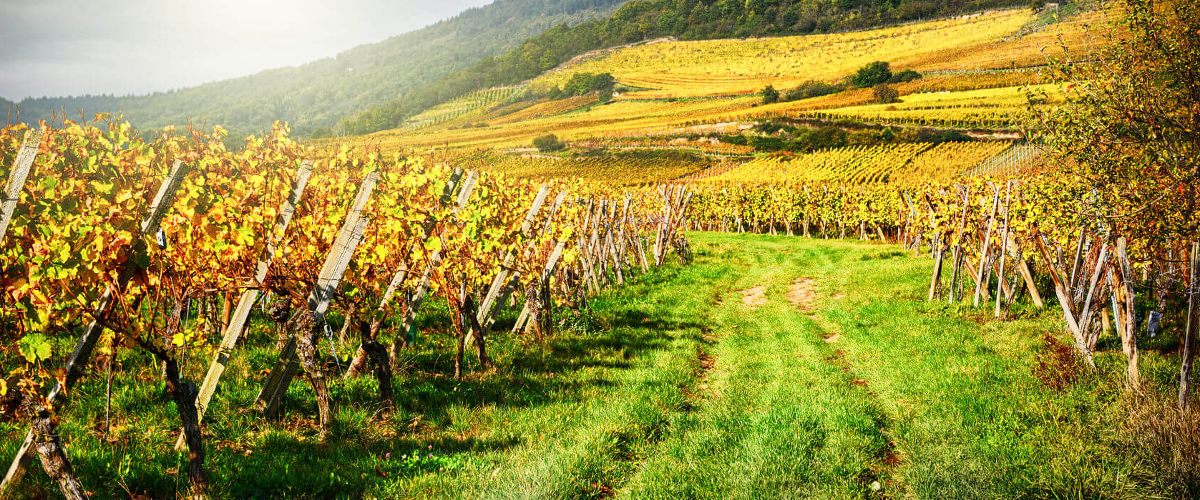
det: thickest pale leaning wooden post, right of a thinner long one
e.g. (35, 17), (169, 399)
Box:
(254, 171), (379, 417)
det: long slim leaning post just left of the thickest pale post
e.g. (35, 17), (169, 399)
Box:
(175, 161), (312, 451)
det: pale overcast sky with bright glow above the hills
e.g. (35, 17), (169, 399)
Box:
(0, 0), (492, 101)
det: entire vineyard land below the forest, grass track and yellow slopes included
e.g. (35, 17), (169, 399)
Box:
(0, 0), (1200, 500)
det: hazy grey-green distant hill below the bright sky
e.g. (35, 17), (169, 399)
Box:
(7, 0), (626, 138)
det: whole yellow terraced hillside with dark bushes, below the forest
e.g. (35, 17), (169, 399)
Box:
(317, 5), (1103, 185)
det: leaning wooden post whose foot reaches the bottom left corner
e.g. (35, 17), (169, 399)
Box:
(0, 159), (187, 498)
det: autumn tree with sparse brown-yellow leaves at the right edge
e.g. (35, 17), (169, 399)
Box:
(1030, 0), (1200, 408)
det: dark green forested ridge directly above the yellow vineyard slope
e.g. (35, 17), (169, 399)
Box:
(341, 0), (1022, 134)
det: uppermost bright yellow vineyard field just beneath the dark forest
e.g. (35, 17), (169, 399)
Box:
(532, 10), (1033, 98)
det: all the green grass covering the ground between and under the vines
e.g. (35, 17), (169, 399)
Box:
(0, 234), (1174, 499)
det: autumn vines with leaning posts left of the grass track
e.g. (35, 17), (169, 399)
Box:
(0, 118), (690, 498)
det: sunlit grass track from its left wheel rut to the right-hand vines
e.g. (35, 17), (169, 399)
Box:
(622, 234), (1152, 499)
